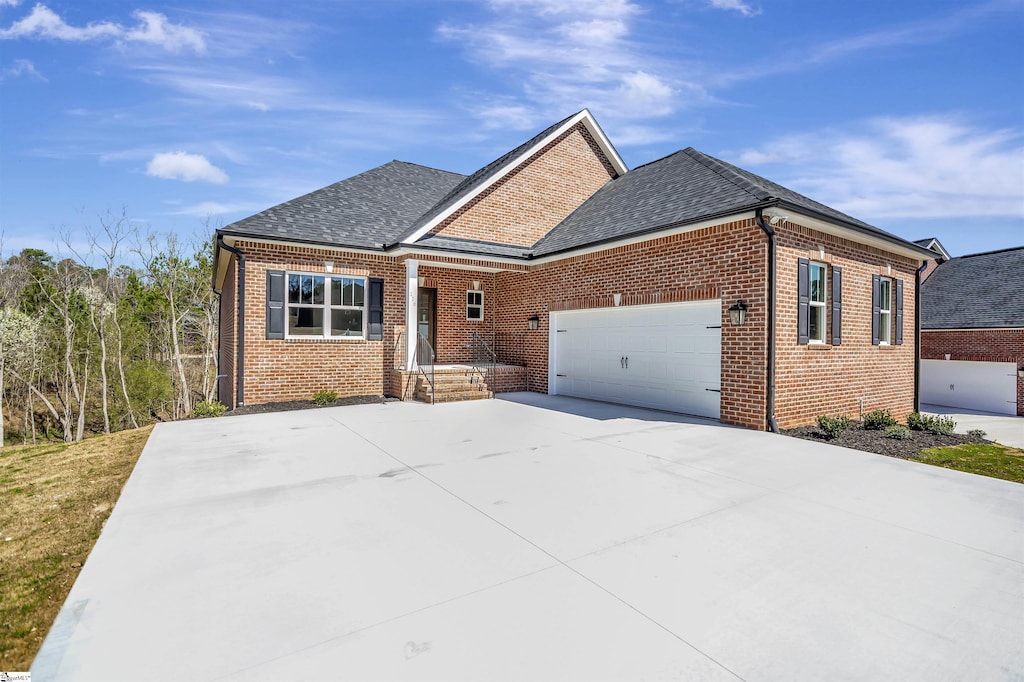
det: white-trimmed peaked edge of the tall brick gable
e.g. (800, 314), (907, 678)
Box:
(400, 109), (629, 244)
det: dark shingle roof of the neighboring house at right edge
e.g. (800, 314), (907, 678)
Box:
(921, 247), (1024, 329)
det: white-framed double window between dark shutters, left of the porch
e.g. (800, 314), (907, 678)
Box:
(287, 272), (367, 338)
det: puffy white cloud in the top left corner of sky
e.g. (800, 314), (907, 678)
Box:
(0, 4), (206, 53)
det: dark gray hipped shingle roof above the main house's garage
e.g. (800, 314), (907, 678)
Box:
(534, 147), (909, 256)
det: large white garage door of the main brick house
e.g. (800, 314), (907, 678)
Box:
(548, 300), (722, 419)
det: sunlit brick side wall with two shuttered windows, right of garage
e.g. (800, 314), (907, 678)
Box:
(775, 223), (919, 428)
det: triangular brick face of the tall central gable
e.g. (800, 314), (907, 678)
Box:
(431, 124), (615, 246)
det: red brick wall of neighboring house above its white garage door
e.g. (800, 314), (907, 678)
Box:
(921, 329), (1024, 417)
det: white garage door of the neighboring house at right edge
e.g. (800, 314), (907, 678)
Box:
(921, 359), (1017, 415)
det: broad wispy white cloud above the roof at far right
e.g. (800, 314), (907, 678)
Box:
(731, 116), (1024, 219)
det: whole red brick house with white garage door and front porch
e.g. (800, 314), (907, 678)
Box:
(214, 110), (935, 429)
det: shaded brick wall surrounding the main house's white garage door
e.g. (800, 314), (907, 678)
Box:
(496, 220), (767, 428)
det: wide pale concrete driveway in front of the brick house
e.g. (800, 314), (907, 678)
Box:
(32, 394), (1024, 682)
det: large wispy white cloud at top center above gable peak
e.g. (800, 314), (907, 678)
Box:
(437, 0), (713, 137)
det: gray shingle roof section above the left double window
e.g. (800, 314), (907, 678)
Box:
(220, 161), (465, 249)
